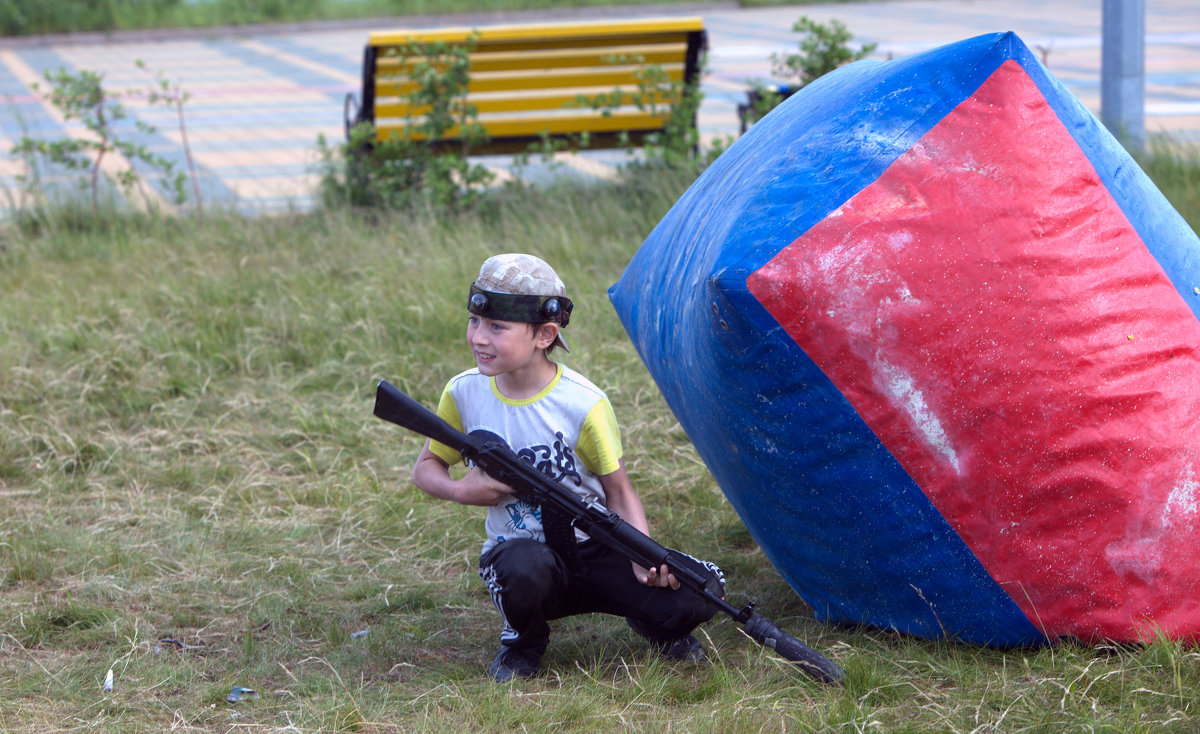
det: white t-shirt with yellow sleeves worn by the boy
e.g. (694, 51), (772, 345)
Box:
(430, 365), (622, 553)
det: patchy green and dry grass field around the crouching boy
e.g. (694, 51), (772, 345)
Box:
(0, 160), (1200, 733)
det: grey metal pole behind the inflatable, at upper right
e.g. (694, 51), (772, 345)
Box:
(1100, 0), (1146, 152)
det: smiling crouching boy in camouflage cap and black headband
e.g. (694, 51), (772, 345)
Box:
(413, 253), (724, 681)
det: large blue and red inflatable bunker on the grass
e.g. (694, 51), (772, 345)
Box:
(610, 34), (1200, 646)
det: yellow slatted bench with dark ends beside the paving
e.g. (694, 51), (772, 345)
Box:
(346, 18), (707, 152)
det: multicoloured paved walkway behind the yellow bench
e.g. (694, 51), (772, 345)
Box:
(0, 0), (1200, 216)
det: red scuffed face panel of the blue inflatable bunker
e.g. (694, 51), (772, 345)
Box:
(749, 61), (1200, 639)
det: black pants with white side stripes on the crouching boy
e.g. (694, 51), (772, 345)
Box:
(479, 539), (724, 655)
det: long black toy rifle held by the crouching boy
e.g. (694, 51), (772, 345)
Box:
(374, 380), (846, 684)
